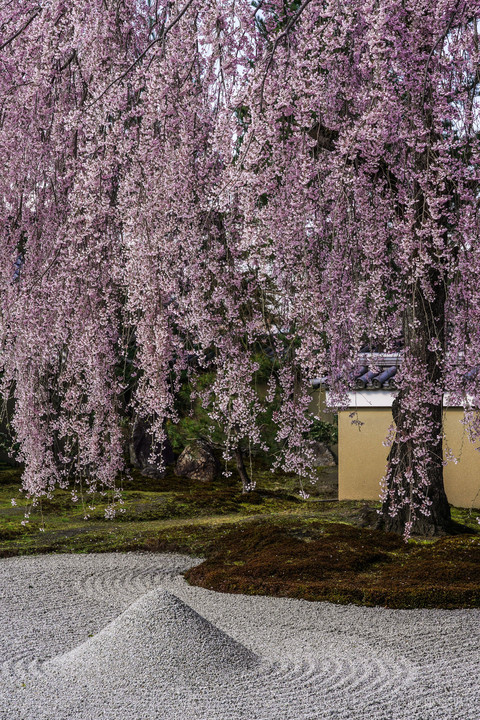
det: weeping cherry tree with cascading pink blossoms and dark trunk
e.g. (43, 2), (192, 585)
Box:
(0, 0), (480, 533)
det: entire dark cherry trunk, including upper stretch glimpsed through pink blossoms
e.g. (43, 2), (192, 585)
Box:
(381, 70), (452, 536)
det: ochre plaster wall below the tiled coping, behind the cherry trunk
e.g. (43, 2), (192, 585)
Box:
(338, 408), (480, 508)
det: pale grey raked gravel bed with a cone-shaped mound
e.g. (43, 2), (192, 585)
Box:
(0, 553), (480, 720)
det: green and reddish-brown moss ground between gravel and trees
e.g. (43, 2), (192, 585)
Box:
(0, 465), (480, 608)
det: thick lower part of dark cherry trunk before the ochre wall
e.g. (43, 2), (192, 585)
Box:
(379, 272), (451, 535)
